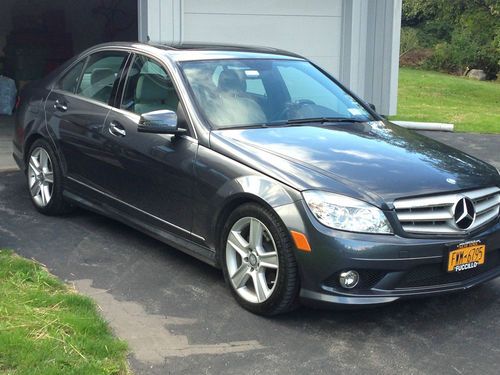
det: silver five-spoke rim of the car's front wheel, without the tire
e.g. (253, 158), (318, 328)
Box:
(226, 217), (279, 303)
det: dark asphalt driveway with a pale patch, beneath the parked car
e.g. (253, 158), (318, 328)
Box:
(0, 116), (500, 375)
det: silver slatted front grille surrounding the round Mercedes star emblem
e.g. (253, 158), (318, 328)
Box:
(394, 187), (500, 234)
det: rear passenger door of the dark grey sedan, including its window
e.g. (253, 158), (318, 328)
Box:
(45, 51), (129, 188)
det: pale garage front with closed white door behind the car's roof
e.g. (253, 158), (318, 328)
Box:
(138, 0), (401, 115)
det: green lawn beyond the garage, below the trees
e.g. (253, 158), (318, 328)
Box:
(391, 68), (500, 133)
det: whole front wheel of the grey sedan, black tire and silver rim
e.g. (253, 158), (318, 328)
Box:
(221, 203), (299, 315)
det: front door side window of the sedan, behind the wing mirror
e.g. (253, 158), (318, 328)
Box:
(120, 55), (179, 115)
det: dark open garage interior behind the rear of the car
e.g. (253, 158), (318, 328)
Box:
(0, 0), (138, 90)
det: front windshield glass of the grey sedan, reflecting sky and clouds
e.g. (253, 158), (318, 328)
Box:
(181, 59), (373, 128)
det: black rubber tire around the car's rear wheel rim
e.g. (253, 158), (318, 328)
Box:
(26, 138), (73, 216)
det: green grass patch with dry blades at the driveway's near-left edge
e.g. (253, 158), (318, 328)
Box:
(0, 250), (129, 375)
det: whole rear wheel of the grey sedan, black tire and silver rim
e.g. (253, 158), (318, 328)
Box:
(26, 139), (71, 215)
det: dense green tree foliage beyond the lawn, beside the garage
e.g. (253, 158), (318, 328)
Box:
(402, 0), (500, 78)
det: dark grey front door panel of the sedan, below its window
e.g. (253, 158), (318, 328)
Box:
(103, 110), (198, 235)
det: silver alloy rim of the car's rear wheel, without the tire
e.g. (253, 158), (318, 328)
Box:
(28, 147), (54, 207)
